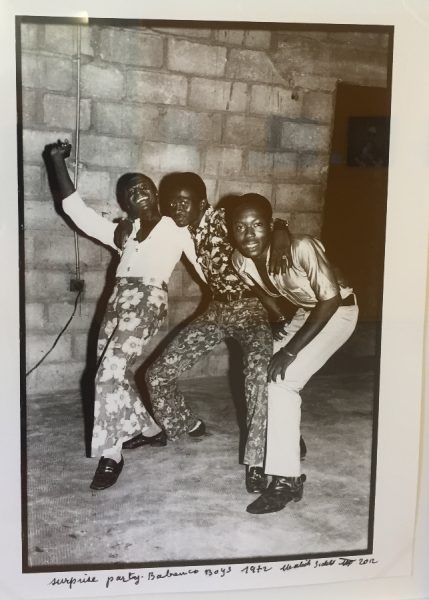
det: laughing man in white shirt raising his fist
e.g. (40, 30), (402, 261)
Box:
(45, 142), (204, 490)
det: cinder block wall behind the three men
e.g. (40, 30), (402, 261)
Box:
(21, 23), (388, 395)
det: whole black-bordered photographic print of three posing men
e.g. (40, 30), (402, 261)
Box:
(0, 1), (428, 596)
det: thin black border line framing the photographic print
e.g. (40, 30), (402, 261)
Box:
(15, 15), (394, 573)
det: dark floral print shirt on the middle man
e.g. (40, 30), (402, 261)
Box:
(189, 206), (249, 294)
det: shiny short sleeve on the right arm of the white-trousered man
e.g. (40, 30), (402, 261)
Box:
(292, 237), (340, 301)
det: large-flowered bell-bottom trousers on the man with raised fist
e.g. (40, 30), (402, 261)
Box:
(91, 277), (168, 457)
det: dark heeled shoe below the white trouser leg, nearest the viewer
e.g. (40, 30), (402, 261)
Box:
(246, 475), (307, 515)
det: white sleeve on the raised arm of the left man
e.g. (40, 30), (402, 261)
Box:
(62, 192), (118, 252)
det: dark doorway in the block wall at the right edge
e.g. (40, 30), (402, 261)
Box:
(322, 83), (390, 330)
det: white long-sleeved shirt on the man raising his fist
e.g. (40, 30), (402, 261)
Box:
(63, 192), (205, 286)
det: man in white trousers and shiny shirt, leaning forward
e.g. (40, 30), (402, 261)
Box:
(231, 194), (359, 514)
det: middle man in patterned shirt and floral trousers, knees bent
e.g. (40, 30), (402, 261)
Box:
(123, 173), (289, 493)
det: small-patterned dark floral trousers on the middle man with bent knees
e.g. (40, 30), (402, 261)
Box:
(146, 298), (273, 466)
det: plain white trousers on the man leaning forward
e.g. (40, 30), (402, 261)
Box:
(265, 306), (359, 477)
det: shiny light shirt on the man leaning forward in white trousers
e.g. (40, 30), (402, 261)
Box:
(232, 235), (353, 309)
